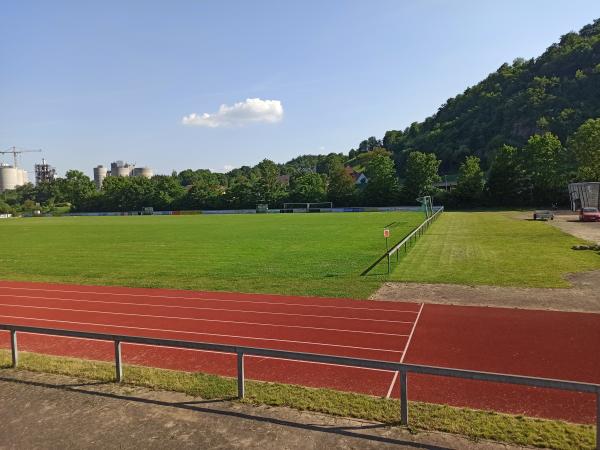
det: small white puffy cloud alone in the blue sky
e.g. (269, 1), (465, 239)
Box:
(181, 98), (283, 128)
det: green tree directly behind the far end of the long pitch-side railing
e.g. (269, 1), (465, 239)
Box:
(404, 152), (441, 201)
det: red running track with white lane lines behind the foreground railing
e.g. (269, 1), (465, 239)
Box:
(0, 281), (600, 423)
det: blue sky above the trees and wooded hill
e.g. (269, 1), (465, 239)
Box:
(0, 0), (600, 175)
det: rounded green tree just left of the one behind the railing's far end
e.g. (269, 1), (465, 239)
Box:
(363, 153), (400, 206)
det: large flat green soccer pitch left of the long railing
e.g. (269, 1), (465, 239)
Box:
(0, 212), (424, 298)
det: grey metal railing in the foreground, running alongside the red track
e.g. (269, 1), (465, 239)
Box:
(0, 324), (600, 450)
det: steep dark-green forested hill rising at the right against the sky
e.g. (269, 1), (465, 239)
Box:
(383, 19), (600, 173)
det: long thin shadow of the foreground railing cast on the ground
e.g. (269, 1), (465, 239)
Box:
(0, 366), (449, 450)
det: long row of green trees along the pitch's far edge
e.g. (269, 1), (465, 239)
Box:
(0, 118), (600, 213)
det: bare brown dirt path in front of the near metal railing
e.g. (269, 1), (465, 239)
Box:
(0, 369), (516, 450)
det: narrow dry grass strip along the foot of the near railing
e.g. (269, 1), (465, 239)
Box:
(0, 350), (595, 449)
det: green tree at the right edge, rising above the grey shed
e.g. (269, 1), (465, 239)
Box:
(568, 118), (600, 181)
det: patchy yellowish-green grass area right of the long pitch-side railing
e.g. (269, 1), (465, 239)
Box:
(392, 212), (600, 287)
